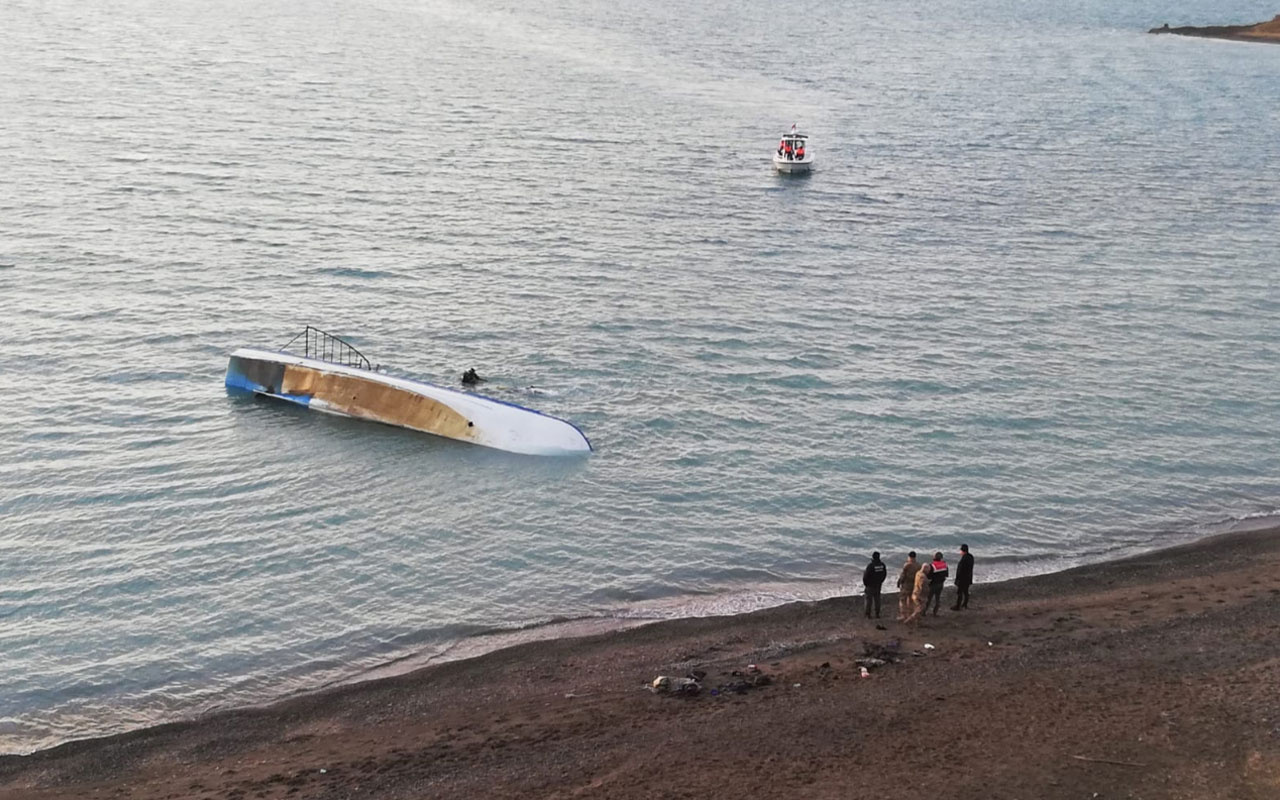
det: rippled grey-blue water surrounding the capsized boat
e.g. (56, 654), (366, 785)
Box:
(0, 0), (1280, 751)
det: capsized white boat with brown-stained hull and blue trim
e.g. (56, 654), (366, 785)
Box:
(227, 325), (591, 456)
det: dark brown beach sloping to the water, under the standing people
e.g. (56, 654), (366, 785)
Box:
(0, 529), (1280, 800)
